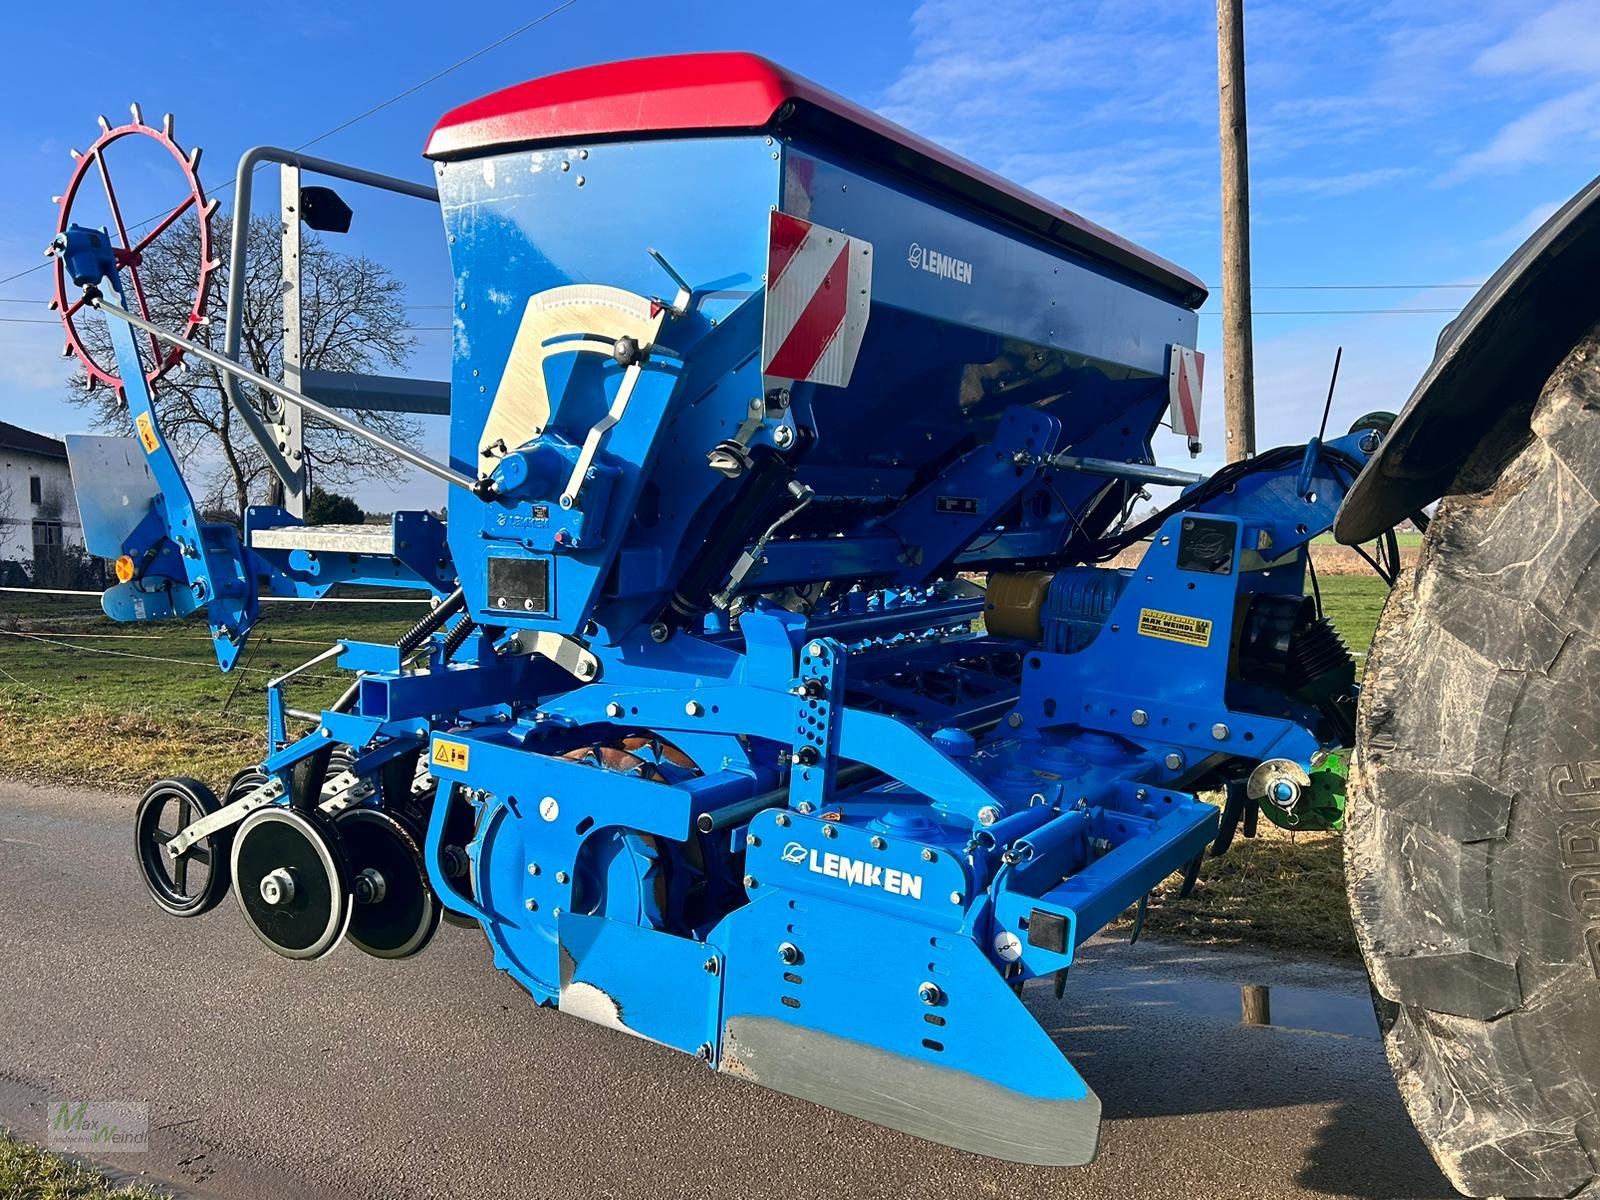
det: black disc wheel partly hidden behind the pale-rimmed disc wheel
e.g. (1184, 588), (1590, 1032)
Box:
(334, 808), (442, 958)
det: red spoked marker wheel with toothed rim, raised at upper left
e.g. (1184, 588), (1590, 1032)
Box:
(50, 104), (221, 392)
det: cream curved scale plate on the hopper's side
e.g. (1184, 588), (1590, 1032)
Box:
(478, 283), (666, 475)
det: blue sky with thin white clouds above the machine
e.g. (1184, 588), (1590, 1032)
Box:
(0, 0), (1600, 509)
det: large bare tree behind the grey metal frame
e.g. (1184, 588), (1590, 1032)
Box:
(69, 218), (421, 517)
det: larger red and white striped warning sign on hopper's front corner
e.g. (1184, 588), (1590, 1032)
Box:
(762, 213), (872, 387)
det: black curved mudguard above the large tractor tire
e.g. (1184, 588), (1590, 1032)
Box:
(1333, 169), (1600, 546)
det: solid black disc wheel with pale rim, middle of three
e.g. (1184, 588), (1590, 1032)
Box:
(234, 805), (352, 958)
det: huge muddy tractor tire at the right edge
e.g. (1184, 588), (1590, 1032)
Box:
(1346, 326), (1600, 1197)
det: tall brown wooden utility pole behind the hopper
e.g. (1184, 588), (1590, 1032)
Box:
(1216, 0), (1256, 462)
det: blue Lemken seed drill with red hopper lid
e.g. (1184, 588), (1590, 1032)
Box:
(56, 54), (1548, 1184)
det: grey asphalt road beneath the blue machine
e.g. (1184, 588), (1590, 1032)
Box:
(0, 784), (1451, 1200)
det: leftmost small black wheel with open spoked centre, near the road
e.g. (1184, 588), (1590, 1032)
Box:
(133, 779), (234, 917)
